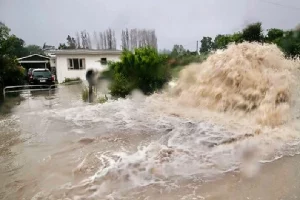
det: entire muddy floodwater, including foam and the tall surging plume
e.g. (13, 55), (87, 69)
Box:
(0, 44), (300, 200)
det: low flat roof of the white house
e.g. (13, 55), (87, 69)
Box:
(47, 49), (122, 55)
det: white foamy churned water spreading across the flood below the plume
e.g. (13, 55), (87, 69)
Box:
(30, 94), (298, 199)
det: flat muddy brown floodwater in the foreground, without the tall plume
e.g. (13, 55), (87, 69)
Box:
(0, 82), (300, 200)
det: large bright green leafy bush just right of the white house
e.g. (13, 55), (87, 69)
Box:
(109, 47), (171, 97)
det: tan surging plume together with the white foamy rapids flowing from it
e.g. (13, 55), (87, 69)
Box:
(24, 43), (300, 199)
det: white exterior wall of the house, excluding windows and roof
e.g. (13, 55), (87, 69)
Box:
(56, 55), (120, 83)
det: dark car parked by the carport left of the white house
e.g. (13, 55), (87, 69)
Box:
(29, 69), (55, 85)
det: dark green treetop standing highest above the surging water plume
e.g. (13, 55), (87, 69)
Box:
(242, 22), (264, 42)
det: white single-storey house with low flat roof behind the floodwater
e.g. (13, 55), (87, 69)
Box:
(48, 49), (122, 83)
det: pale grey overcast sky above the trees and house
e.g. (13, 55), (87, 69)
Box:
(0, 0), (300, 50)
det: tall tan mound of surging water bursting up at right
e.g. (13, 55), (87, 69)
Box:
(173, 42), (295, 126)
